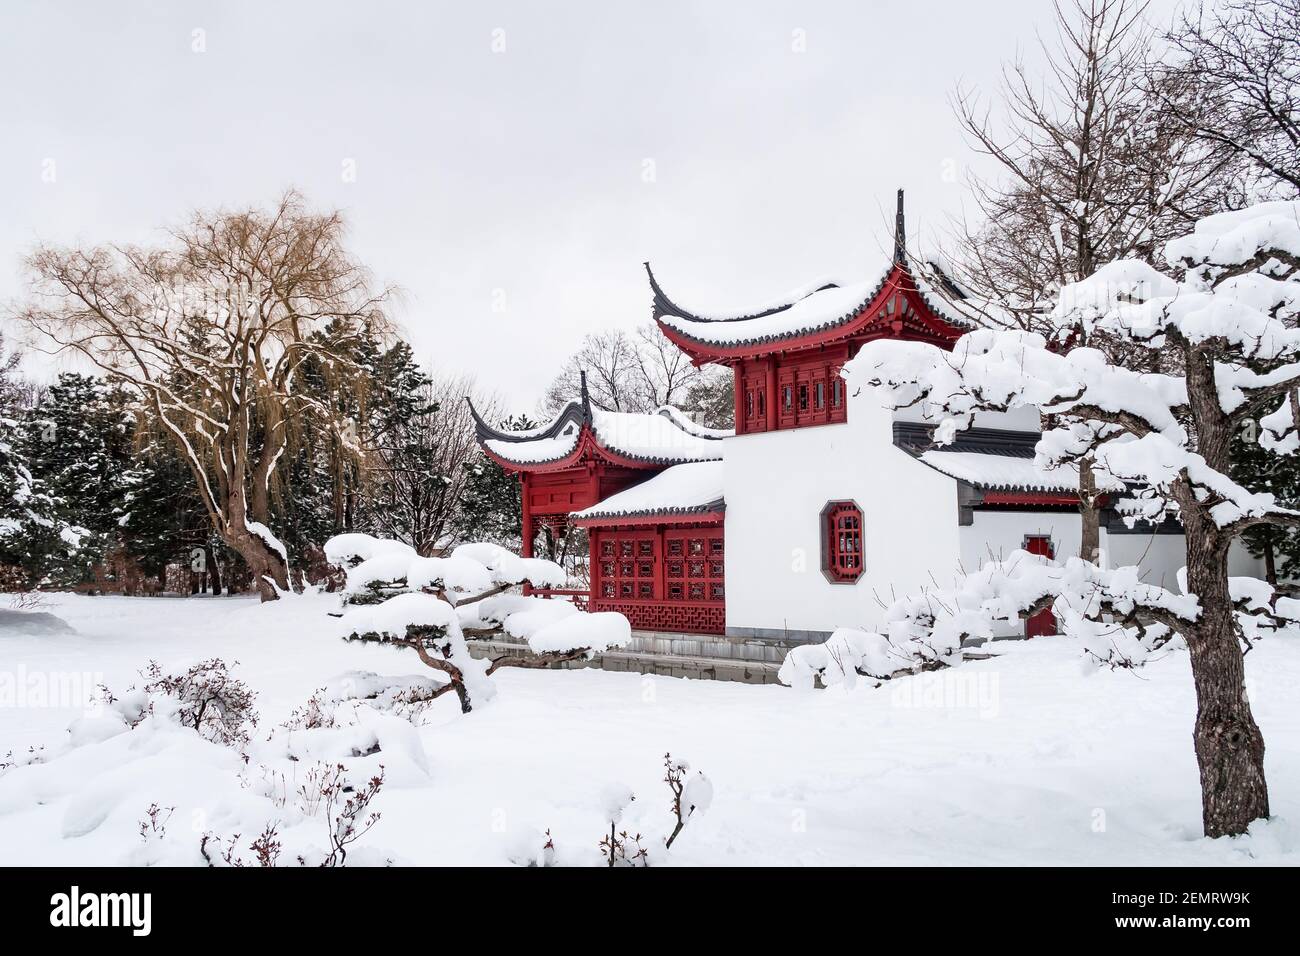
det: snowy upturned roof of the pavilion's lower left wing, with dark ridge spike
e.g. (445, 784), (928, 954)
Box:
(471, 389), (731, 466)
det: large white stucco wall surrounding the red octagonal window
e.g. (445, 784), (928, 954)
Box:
(723, 392), (959, 636)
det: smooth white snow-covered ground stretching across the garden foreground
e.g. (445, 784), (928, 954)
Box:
(0, 596), (1300, 865)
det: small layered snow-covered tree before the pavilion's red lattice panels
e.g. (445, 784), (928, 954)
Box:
(325, 535), (632, 713)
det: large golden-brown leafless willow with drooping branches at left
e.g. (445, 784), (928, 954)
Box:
(16, 191), (390, 601)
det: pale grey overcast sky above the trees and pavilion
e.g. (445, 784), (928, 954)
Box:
(0, 0), (1180, 410)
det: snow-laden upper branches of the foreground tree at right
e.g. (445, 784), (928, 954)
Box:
(844, 202), (1300, 533)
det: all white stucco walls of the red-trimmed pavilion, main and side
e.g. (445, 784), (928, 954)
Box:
(723, 390), (1262, 639)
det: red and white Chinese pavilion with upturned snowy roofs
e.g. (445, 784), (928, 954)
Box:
(475, 190), (1237, 640)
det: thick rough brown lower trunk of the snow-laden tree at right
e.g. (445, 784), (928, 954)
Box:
(1184, 515), (1269, 836)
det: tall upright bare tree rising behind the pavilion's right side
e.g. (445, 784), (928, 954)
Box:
(951, 0), (1239, 559)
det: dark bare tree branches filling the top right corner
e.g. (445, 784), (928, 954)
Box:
(1149, 0), (1300, 198)
